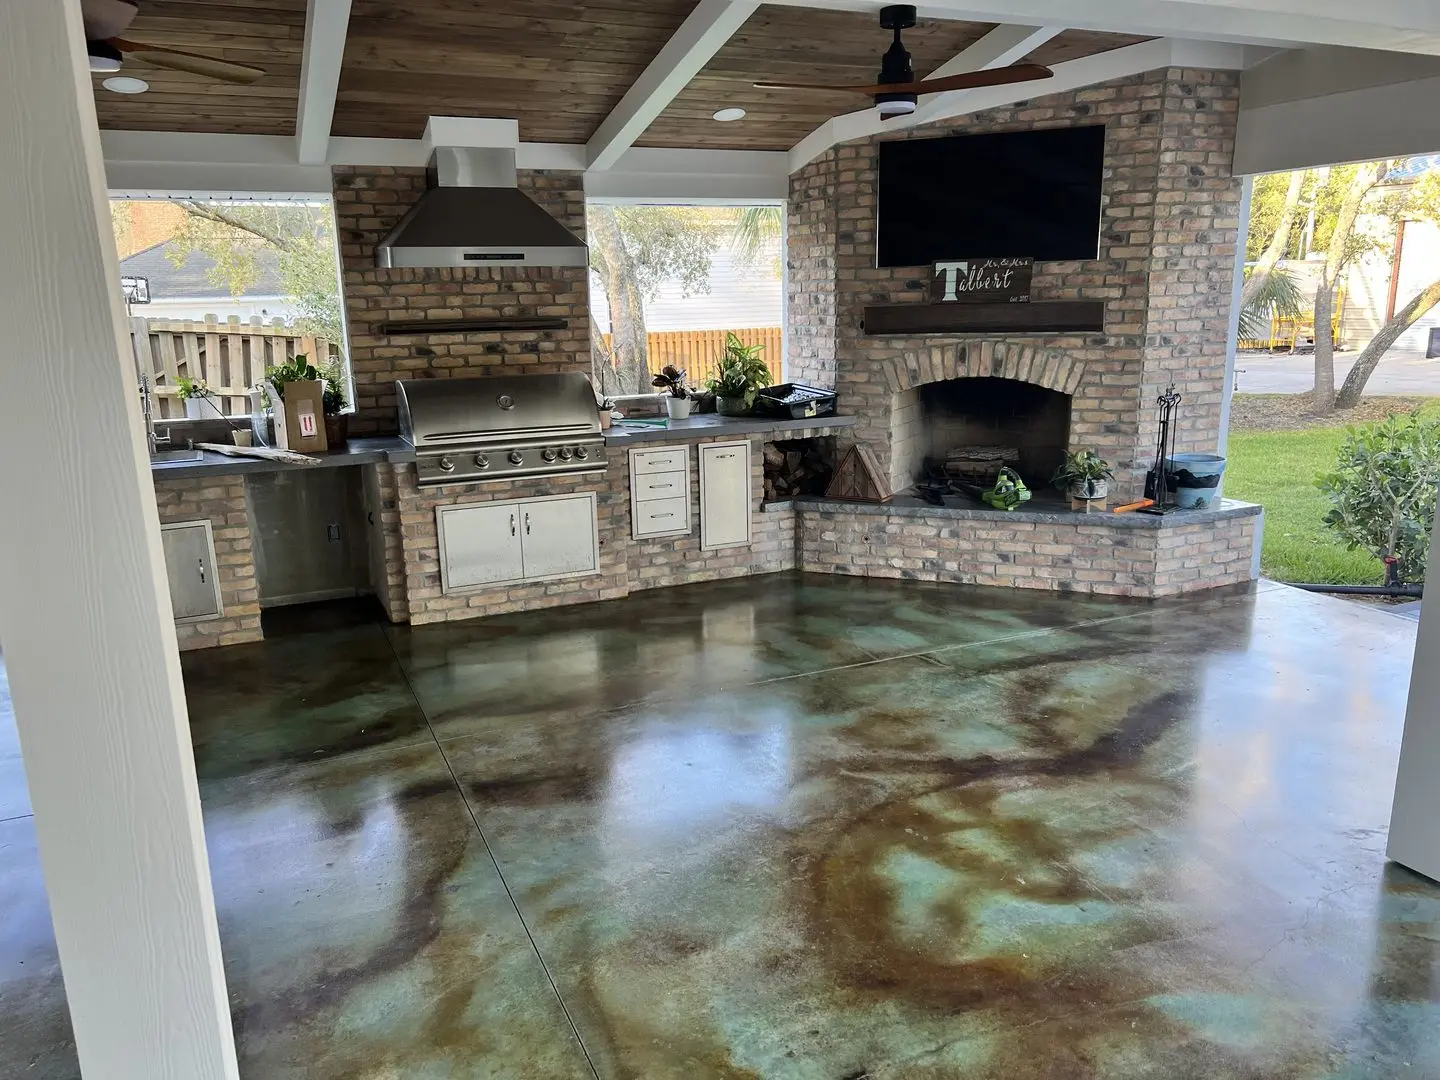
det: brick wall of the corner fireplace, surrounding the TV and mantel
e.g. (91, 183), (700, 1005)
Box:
(789, 68), (1240, 494)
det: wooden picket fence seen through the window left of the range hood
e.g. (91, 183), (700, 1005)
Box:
(130, 315), (340, 419)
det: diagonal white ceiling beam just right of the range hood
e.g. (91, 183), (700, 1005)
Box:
(586, 0), (759, 168)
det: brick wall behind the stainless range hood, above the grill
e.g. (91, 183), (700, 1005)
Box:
(333, 166), (590, 435)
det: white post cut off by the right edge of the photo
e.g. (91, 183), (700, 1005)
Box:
(1385, 495), (1440, 881)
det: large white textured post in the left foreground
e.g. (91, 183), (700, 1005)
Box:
(0, 0), (239, 1080)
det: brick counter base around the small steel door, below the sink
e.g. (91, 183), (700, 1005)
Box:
(156, 477), (262, 651)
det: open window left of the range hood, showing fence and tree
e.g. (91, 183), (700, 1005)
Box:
(111, 196), (353, 419)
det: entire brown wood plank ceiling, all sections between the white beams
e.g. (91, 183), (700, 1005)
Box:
(87, 0), (1143, 150)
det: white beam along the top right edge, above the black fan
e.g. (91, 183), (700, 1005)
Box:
(768, 0), (1440, 55)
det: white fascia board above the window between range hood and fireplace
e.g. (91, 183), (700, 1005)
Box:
(585, 147), (791, 203)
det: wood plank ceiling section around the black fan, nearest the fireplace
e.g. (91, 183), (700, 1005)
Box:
(636, 4), (1145, 150)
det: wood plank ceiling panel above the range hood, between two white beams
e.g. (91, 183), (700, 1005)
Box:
(334, 0), (694, 143)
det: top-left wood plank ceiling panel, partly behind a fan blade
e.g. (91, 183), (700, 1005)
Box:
(91, 0), (305, 135)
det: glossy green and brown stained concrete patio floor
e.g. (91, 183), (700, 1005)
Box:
(0, 576), (1440, 1080)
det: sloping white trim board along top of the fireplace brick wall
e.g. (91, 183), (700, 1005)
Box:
(789, 39), (1192, 173)
